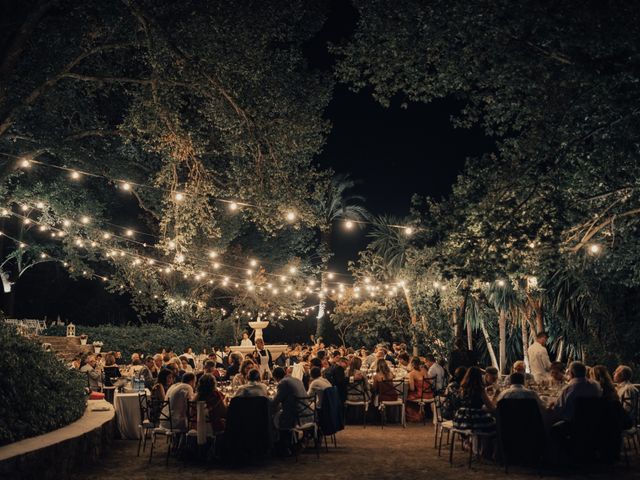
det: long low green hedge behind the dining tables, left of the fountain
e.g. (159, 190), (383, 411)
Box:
(45, 324), (233, 359)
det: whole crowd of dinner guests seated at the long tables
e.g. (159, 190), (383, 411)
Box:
(73, 332), (639, 460)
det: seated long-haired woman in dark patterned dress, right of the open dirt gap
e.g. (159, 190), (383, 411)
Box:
(453, 367), (495, 432)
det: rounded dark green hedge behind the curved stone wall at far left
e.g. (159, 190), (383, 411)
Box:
(0, 324), (87, 445)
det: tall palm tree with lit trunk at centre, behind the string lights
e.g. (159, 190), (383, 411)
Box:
(315, 174), (369, 338)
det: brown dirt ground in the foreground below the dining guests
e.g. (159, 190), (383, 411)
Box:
(73, 425), (640, 480)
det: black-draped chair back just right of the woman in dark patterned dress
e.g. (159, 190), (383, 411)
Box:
(496, 398), (547, 465)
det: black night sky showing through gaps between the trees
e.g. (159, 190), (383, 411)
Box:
(3, 0), (492, 324)
